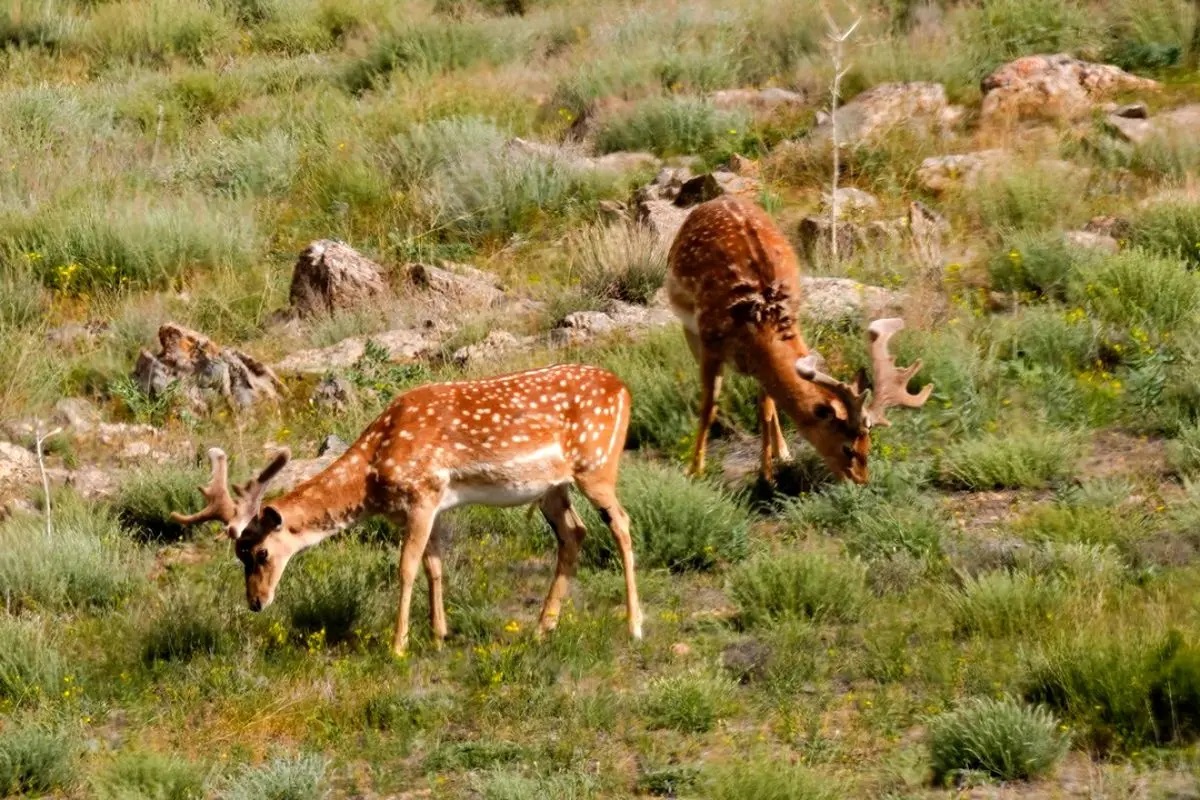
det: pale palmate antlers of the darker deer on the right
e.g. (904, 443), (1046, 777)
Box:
(796, 317), (934, 431)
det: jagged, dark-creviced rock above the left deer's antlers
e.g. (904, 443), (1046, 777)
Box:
(133, 323), (283, 411)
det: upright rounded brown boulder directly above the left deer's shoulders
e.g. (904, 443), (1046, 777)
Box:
(289, 239), (388, 317)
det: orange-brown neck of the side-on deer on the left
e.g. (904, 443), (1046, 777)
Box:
(269, 446), (368, 549)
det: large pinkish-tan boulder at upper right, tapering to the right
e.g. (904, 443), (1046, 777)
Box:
(979, 53), (1158, 127)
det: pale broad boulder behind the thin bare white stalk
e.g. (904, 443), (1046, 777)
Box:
(808, 83), (961, 146)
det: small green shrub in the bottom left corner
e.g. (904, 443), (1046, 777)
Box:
(0, 721), (77, 795)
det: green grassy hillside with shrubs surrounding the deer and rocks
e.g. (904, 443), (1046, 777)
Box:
(0, 0), (1200, 800)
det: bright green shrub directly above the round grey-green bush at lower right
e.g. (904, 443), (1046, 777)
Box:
(946, 570), (1063, 637)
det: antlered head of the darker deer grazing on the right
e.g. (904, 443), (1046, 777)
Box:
(796, 318), (934, 483)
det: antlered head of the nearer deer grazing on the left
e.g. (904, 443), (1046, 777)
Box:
(170, 447), (292, 612)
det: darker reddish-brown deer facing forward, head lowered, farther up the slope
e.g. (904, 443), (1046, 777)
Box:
(666, 196), (934, 483)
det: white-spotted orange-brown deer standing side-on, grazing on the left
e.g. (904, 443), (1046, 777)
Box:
(175, 365), (642, 655)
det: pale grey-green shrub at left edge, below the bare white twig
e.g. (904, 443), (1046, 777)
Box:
(0, 494), (145, 610)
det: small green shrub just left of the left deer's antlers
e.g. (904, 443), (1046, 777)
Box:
(113, 467), (211, 540)
